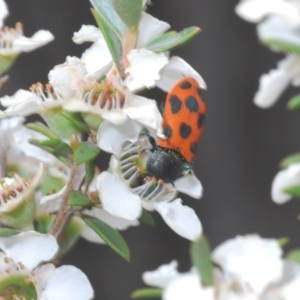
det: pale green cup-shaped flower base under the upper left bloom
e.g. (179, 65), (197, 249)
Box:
(41, 108), (81, 141)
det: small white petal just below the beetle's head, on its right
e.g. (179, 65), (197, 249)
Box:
(174, 174), (203, 199)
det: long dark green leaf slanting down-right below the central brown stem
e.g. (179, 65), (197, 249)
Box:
(82, 215), (130, 261)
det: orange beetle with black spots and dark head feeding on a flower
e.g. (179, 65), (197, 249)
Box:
(146, 77), (206, 182)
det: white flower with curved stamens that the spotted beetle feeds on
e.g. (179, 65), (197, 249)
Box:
(97, 136), (202, 240)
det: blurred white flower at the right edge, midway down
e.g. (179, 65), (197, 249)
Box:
(271, 163), (300, 204)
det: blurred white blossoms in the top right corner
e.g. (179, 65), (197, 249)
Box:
(236, 0), (300, 108)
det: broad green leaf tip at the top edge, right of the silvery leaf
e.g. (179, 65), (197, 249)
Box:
(112, 0), (143, 30)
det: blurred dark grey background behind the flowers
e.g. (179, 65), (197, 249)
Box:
(3, 0), (300, 300)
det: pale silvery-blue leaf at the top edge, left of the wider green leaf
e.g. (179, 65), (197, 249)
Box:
(90, 0), (127, 40)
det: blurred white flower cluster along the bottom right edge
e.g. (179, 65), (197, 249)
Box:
(143, 235), (300, 300)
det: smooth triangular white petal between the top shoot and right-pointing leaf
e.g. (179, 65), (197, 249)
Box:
(136, 12), (171, 48)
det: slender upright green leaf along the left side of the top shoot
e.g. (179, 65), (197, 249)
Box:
(92, 9), (123, 70)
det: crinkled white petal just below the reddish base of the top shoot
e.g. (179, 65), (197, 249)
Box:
(125, 49), (168, 91)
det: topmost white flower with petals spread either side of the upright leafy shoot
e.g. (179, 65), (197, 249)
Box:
(73, 12), (206, 92)
